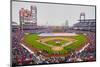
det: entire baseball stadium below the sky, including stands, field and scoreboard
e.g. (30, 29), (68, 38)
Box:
(11, 6), (96, 66)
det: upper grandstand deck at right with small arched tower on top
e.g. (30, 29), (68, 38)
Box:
(73, 13), (96, 32)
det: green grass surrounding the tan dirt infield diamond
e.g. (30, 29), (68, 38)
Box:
(24, 34), (86, 54)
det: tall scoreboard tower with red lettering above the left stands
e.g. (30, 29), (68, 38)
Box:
(19, 6), (37, 32)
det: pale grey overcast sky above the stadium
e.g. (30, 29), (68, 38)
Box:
(12, 1), (95, 26)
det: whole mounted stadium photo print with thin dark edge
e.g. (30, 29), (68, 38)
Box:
(11, 0), (96, 66)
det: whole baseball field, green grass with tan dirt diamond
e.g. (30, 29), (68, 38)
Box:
(23, 34), (87, 54)
